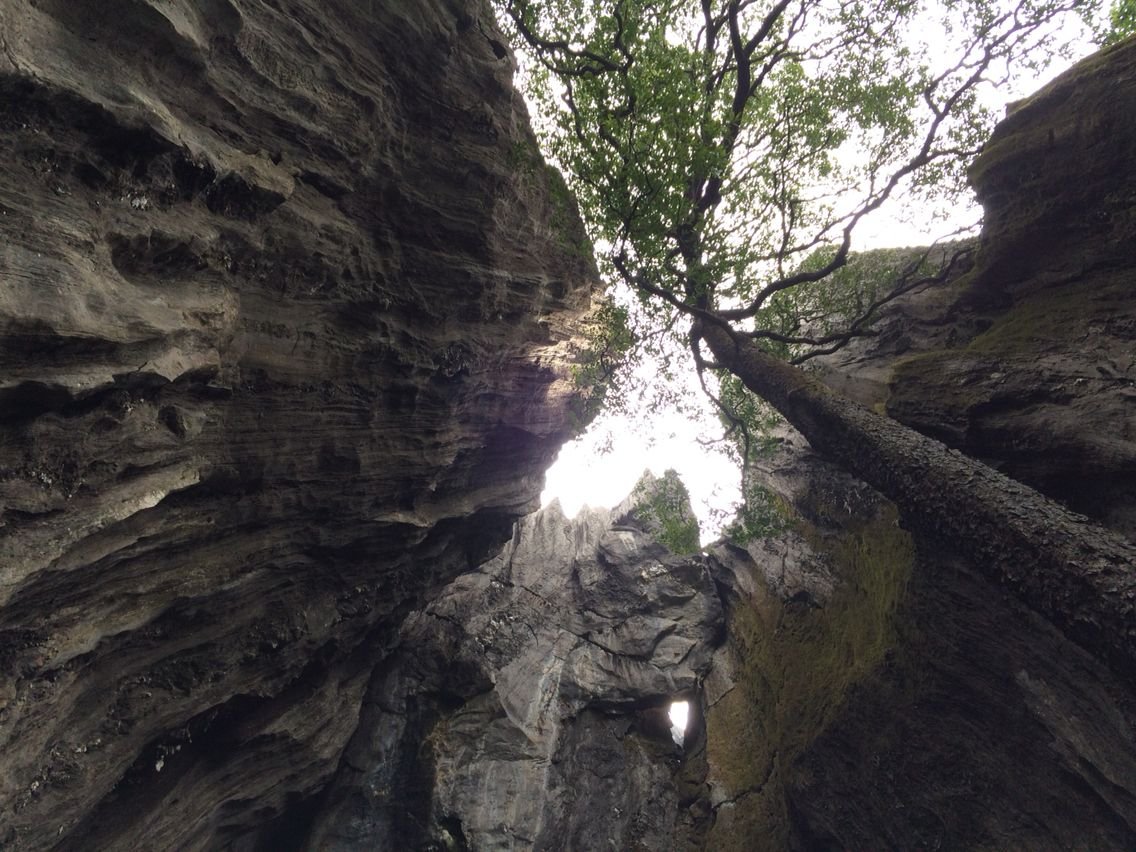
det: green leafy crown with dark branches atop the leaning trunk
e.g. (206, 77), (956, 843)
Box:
(495, 0), (1099, 527)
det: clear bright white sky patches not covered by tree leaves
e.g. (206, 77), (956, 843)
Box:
(541, 11), (1092, 544)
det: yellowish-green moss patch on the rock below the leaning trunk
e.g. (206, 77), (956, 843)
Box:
(707, 508), (914, 850)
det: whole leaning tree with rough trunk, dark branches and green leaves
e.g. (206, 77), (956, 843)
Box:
(496, 0), (1136, 673)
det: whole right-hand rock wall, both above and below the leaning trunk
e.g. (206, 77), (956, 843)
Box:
(703, 41), (1136, 850)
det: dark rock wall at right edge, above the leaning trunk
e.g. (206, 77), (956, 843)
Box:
(887, 40), (1136, 537)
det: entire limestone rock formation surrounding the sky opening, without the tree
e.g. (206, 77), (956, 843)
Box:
(0, 0), (1136, 851)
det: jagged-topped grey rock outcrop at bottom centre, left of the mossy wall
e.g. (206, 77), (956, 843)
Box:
(307, 481), (721, 850)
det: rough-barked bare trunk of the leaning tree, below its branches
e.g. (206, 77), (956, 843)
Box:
(699, 321), (1136, 676)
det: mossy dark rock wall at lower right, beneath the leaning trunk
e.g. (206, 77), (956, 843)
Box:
(696, 443), (1136, 850)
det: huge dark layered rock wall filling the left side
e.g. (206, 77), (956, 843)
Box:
(0, 0), (594, 850)
